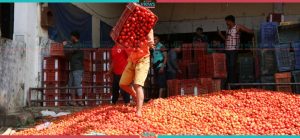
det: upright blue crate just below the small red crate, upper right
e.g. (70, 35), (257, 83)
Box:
(260, 22), (279, 48)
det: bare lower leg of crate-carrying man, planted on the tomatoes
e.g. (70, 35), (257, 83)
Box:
(134, 84), (144, 116)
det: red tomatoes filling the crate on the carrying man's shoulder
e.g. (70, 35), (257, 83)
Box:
(117, 6), (157, 48)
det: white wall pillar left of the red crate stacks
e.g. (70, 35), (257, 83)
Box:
(14, 3), (41, 108)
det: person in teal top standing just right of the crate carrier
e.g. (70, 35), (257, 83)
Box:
(153, 36), (168, 98)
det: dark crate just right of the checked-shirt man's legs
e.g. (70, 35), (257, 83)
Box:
(239, 56), (255, 83)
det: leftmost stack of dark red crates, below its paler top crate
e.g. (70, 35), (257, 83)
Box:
(42, 56), (69, 106)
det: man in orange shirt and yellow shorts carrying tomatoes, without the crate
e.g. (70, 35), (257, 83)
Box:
(120, 29), (155, 117)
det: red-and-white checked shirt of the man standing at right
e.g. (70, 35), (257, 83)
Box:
(225, 25), (240, 50)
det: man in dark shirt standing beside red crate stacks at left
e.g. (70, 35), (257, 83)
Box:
(64, 32), (83, 106)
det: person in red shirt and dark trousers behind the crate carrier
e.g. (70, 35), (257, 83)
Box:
(105, 45), (130, 105)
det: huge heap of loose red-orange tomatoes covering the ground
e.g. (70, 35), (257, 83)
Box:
(16, 89), (300, 135)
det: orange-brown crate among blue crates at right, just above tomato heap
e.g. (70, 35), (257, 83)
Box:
(275, 72), (292, 92)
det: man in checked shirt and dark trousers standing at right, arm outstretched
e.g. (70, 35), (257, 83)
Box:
(217, 15), (253, 86)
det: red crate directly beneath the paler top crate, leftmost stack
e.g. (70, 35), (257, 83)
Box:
(43, 57), (69, 70)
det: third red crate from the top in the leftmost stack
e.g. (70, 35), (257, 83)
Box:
(43, 70), (69, 82)
